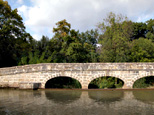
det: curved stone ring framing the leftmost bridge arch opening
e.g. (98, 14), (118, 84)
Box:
(42, 73), (83, 88)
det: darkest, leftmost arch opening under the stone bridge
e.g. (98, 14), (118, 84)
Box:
(45, 76), (81, 89)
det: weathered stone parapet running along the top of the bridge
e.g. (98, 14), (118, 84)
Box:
(0, 63), (154, 76)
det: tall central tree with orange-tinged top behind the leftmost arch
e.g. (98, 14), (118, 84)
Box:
(50, 19), (71, 62)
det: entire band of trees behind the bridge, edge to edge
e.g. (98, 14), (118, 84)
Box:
(0, 5), (154, 67)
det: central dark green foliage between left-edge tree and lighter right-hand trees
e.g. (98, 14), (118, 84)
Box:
(18, 20), (98, 65)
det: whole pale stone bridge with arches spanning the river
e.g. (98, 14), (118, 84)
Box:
(0, 63), (154, 89)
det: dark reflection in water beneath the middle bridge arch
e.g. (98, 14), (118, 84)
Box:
(88, 90), (123, 103)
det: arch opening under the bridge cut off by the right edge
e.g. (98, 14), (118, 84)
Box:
(133, 76), (154, 88)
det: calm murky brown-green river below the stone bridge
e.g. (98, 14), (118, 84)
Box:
(0, 89), (154, 115)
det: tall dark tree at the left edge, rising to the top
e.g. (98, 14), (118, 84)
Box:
(0, 0), (32, 67)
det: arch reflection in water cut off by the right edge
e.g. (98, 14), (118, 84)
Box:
(133, 90), (154, 103)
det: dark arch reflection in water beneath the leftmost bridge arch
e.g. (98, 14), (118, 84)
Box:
(45, 90), (82, 104)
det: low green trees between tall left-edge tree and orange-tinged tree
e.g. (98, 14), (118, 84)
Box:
(18, 36), (52, 65)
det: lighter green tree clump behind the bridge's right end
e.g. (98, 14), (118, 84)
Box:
(98, 13), (154, 62)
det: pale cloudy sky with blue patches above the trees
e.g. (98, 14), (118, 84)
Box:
(5, 0), (154, 40)
